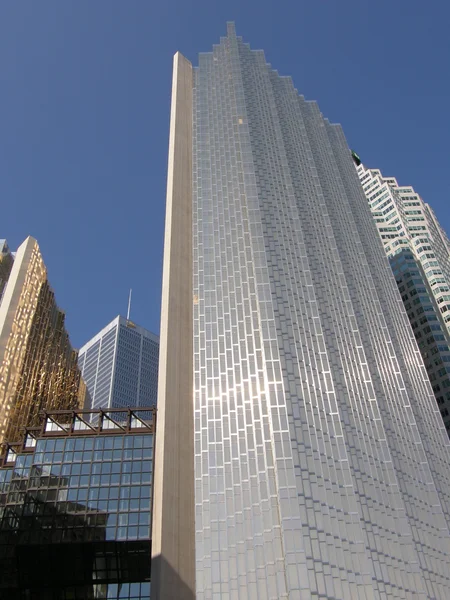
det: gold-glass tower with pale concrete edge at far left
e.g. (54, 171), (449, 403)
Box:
(0, 237), (84, 443)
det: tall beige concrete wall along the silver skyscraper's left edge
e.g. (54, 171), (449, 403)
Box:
(152, 53), (195, 600)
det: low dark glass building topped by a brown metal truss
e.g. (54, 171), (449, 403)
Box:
(0, 408), (155, 600)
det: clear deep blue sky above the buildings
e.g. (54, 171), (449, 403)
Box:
(0, 0), (450, 347)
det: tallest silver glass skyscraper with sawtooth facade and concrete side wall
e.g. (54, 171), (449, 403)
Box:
(152, 24), (450, 600)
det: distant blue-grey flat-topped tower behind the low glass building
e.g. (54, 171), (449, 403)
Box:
(78, 316), (159, 408)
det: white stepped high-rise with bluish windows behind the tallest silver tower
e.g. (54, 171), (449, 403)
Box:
(354, 155), (450, 435)
